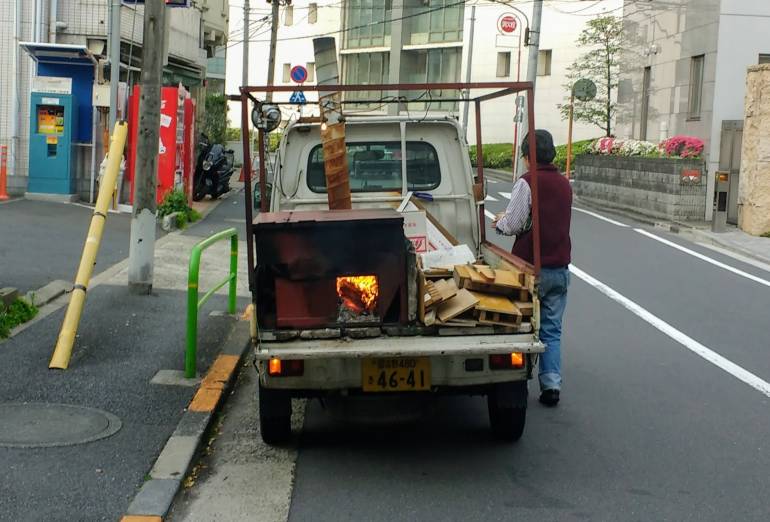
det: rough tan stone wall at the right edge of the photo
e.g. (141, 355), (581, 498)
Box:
(738, 65), (770, 236)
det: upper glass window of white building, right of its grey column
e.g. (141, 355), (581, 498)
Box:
(404, 0), (465, 45)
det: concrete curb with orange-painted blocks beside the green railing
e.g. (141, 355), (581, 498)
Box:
(120, 321), (251, 522)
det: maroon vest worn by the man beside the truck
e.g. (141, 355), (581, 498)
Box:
(511, 165), (572, 268)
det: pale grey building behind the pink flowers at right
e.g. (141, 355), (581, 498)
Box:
(617, 0), (770, 222)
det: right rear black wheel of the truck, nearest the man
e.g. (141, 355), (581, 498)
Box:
(487, 381), (527, 442)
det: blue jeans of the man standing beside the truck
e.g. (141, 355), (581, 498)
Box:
(538, 268), (570, 390)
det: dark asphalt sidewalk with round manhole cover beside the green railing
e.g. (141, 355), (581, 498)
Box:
(0, 191), (249, 521)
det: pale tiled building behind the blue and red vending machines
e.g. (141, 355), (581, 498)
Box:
(0, 0), (229, 199)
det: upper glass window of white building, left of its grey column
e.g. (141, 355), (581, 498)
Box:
(344, 0), (393, 49)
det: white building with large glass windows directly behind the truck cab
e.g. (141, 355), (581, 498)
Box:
(227, 0), (623, 143)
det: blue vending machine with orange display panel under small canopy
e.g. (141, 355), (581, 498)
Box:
(27, 87), (78, 195)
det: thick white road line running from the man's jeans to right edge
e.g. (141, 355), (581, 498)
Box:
(570, 265), (770, 397)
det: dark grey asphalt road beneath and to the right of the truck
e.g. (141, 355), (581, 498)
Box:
(176, 176), (770, 522)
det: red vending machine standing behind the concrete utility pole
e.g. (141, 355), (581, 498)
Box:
(128, 85), (195, 204)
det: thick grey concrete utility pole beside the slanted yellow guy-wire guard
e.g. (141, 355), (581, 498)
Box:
(128, 0), (165, 295)
